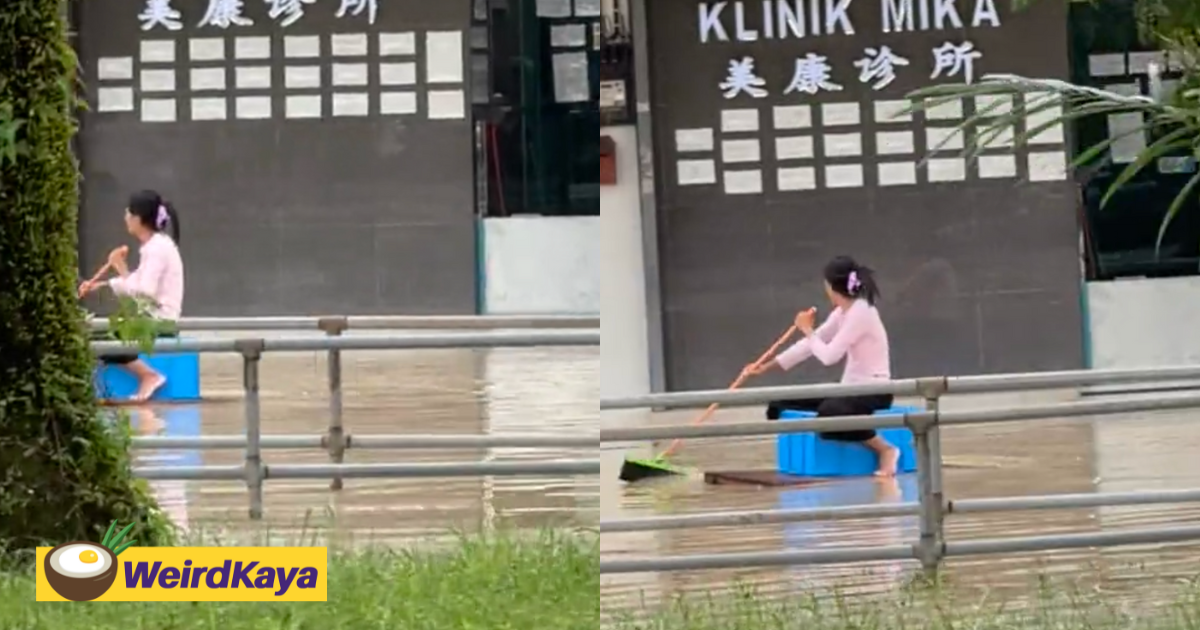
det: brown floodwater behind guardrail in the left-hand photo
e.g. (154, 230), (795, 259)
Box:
(124, 347), (599, 542)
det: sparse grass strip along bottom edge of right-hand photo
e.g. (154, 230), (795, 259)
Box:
(605, 582), (1200, 630)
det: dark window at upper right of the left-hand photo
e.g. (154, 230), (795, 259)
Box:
(472, 0), (600, 216)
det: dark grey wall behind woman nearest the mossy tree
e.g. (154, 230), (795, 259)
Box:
(74, 0), (476, 316)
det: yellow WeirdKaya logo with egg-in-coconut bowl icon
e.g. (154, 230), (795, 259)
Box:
(37, 518), (328, 601)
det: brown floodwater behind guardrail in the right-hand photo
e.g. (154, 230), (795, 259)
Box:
(600, 392), (1200, 611)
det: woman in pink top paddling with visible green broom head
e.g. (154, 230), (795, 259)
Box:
(745, 257), (900, 476)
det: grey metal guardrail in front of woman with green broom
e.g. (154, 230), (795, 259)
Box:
(600, 366), (1200, 574)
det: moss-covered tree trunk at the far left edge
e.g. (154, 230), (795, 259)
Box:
(0, 0), (168, 562)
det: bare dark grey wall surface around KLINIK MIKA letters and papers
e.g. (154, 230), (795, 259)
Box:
(648, 0), (1082, 389)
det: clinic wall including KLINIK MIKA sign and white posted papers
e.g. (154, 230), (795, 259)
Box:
(646, 0), (1082, 390)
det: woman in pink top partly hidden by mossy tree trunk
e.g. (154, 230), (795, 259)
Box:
(79, 191), (184, 402)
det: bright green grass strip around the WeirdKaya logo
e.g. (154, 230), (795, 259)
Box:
(0, 532), (600, 630)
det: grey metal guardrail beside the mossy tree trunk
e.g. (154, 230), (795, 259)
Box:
(91, 318), (600, 520)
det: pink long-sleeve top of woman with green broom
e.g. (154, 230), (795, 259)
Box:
(775, 300), (892, 383)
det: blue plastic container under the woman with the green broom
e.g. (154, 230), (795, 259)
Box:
(776, 407), (923, 476)
